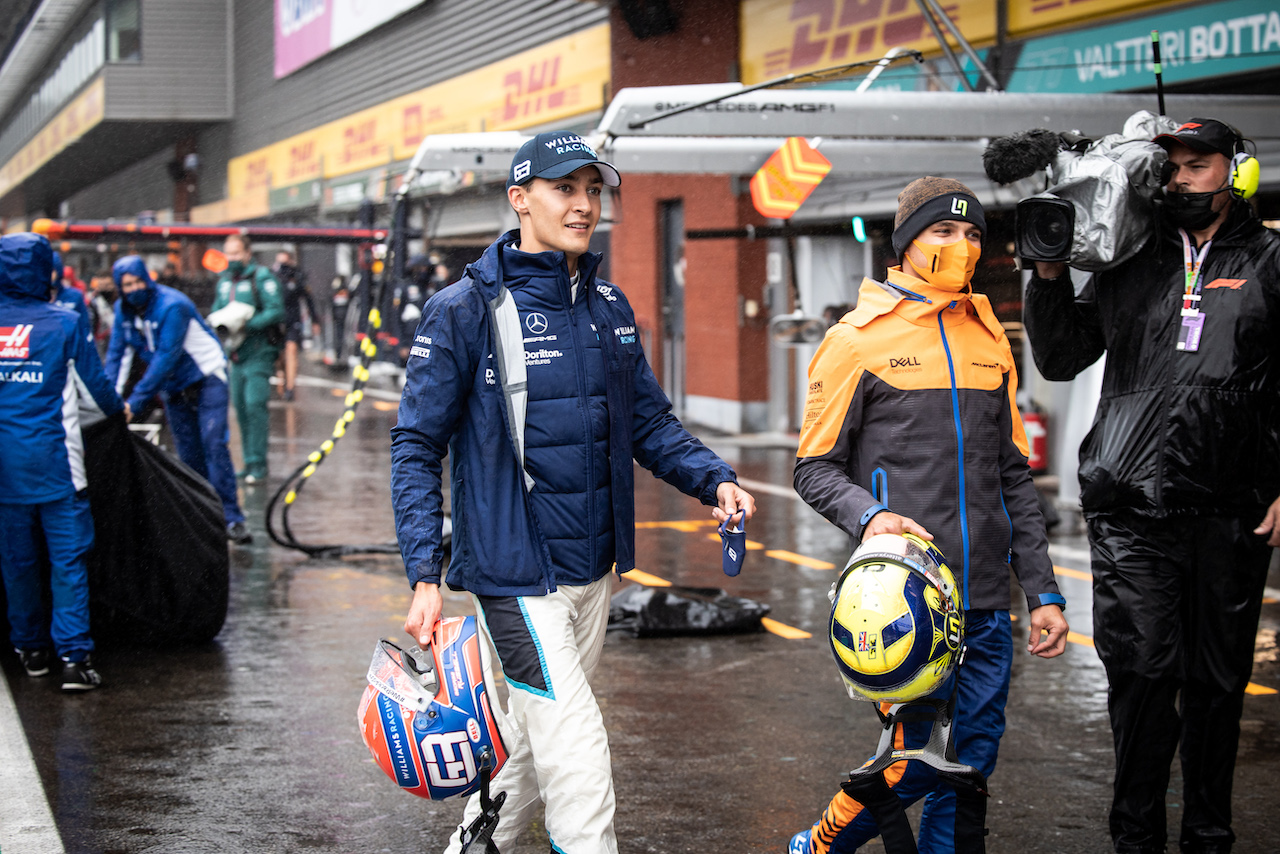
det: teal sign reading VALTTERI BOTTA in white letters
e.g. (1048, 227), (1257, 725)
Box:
(1006, 0), (1280, 93)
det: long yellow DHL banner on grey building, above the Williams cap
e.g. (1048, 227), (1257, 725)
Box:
(228, 24), (609, 198)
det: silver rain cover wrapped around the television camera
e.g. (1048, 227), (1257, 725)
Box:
(1044, 110), (1178, 273)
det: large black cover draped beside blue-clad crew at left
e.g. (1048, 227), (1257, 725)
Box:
(83, 416), (230, 643)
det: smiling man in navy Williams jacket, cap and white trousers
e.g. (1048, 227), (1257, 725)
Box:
(392, 132), (755, 854)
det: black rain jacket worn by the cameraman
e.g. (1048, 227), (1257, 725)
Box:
(1024, 202), (1280, 519)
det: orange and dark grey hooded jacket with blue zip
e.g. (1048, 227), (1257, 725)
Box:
(795, 269), (1065, 609)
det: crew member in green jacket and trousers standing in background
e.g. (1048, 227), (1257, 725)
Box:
(212, 234), (284, 484)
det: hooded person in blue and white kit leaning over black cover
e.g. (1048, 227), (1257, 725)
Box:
(106, 255), (253, 544)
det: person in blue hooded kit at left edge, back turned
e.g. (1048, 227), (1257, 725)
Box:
(0, 234), (125, 691)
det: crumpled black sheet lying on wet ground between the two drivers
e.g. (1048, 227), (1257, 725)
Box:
(609, 585), (769, 638)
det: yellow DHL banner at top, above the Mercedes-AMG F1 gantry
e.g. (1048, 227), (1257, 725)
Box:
(740, 0), (1180, 85)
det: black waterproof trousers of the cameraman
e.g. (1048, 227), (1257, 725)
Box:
(1088, 511), (1271, 851)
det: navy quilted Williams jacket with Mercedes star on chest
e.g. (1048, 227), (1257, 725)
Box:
(392, 230), (736, 595)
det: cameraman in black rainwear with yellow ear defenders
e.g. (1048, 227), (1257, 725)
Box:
(1024, 119), (1280, 853)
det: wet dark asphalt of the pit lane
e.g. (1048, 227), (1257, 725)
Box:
(3, 367), (1280, 854)
